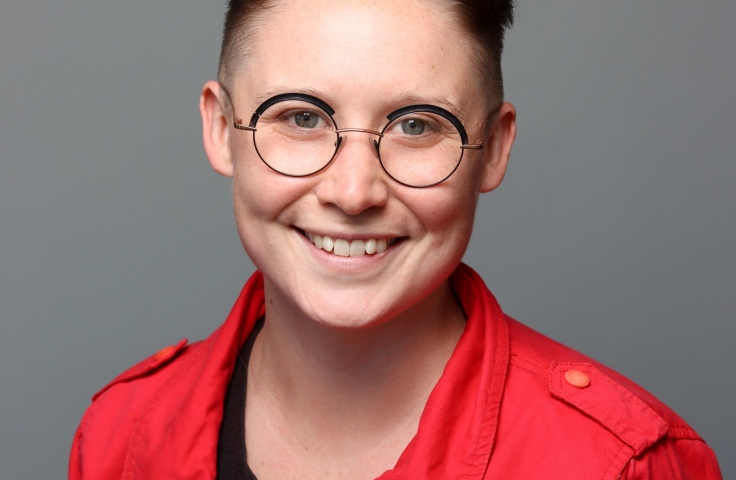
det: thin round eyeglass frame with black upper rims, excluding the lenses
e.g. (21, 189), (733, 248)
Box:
(221, 86), (498, 188)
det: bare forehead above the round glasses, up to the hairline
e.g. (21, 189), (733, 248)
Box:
(233, 0), (483, 119)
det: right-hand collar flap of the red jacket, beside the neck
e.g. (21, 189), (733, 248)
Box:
(380, 264), (509, 480)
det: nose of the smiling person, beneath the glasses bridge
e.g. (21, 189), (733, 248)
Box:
(316, 129), (388, 215)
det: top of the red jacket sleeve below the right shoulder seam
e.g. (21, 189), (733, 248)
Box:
(621, 437), (723, 480)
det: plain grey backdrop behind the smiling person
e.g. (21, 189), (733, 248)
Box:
(0, 0), (736, 479)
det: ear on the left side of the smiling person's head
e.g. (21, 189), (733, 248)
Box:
(199, 80), (233, 177)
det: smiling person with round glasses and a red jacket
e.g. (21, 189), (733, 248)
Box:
(69, 0), (720, 480)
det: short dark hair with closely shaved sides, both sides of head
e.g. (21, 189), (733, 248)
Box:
(217, 0), (515, 103)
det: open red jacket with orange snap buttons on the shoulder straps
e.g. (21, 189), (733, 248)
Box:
(69, 265), (721, 480)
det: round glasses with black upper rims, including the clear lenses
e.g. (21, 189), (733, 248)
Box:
(228, 93), (483, 188)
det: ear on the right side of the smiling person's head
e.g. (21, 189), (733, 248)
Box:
(480, 102), (516, 193)
